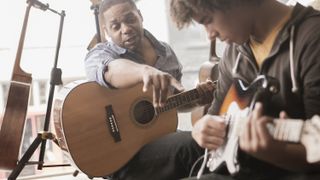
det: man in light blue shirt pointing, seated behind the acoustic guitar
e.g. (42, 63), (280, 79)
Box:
(85, 0), (212, 180)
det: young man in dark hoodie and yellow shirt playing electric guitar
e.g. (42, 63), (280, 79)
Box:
(171, 0), (320, 179)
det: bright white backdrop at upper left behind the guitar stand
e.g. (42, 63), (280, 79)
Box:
(0, 0), (95, 80)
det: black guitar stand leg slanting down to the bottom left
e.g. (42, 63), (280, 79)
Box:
(8, 134), (42, 180)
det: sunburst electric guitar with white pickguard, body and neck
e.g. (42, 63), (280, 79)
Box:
(207, 76), (320, 174)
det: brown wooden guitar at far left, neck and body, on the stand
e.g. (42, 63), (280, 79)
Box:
(0, 3), (32, 170)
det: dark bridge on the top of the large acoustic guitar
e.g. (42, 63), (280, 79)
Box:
(105, 105), (121, 142)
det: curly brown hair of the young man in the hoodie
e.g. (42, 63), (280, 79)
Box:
(170, 0), (262, 29)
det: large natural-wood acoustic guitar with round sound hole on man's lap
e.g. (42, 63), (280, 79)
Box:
(54, 81), (216, 177)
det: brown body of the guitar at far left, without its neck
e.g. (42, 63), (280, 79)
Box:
(0, 78), (31, 170)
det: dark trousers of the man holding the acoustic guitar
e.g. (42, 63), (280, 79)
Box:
(112, 131), (204, 180)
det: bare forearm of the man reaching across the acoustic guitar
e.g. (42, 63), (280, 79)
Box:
(104, 59), (151, 88)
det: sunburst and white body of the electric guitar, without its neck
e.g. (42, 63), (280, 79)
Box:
(207, 75), (279, 174)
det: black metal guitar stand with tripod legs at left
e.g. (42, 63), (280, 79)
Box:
(8, 0), (70, 180)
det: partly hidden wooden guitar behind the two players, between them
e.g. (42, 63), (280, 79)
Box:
(191, 40), (219, 125)
